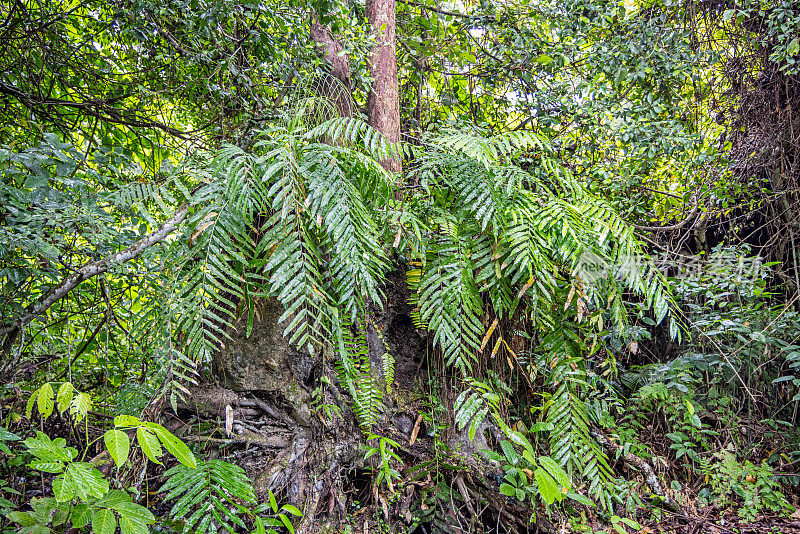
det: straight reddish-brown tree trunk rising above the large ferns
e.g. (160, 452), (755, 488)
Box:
(367, 0), (402, 172)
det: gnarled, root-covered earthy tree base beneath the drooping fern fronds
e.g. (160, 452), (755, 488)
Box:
(197, 274), (530, 534)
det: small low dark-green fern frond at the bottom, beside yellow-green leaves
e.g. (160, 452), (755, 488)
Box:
(159, 460), (256, 534)
